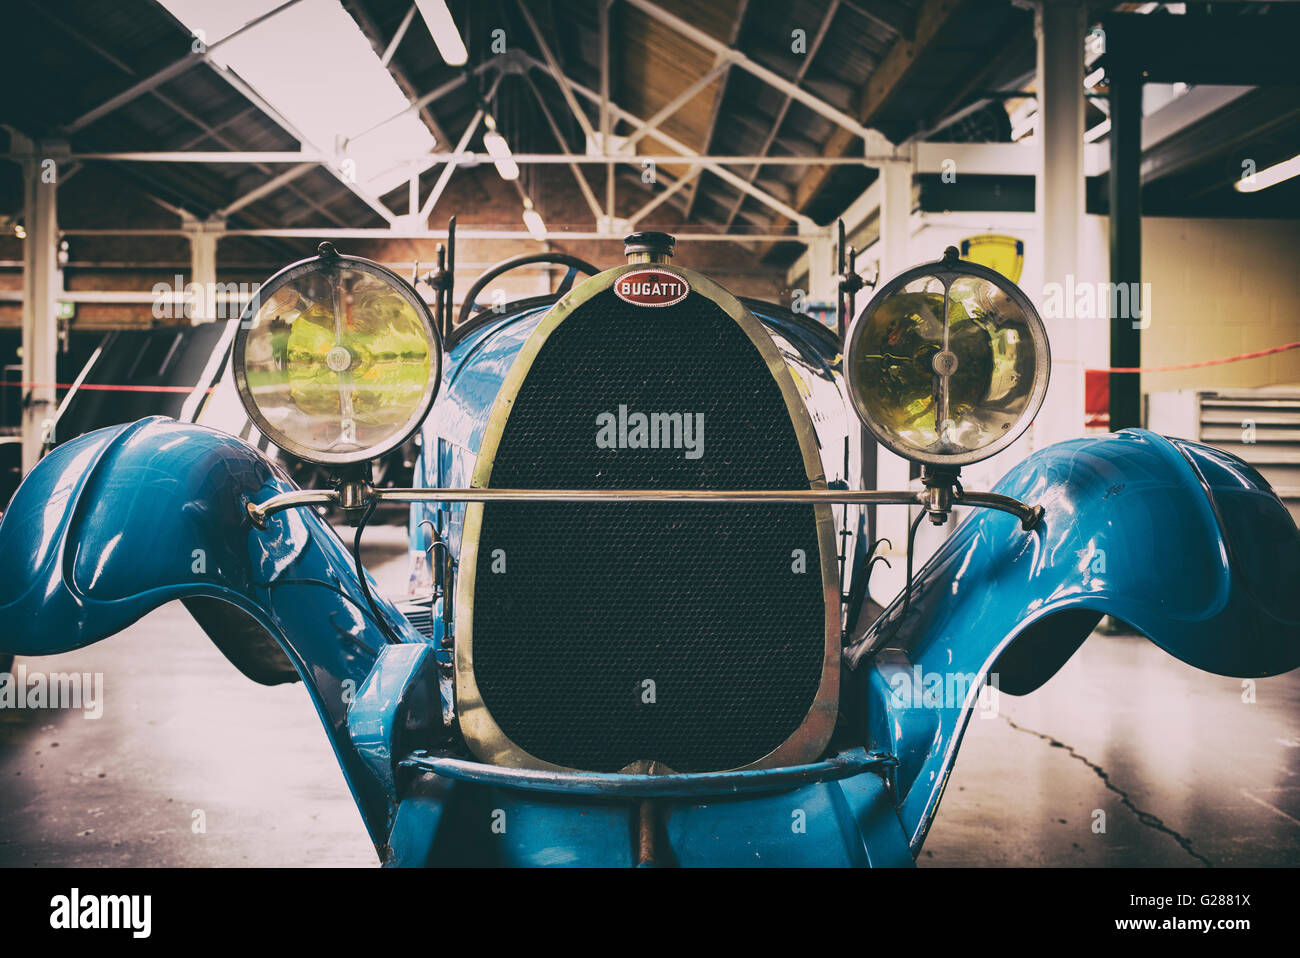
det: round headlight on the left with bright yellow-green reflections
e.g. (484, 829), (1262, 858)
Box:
(233, 244), (442, 465)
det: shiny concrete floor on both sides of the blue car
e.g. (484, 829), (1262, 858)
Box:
(0, 526), (1300, 866)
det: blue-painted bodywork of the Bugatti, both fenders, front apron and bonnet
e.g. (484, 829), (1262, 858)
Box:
(0, 319), (1300, 866)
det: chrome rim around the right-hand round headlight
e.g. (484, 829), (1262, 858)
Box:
(841, 247), (1052, 468)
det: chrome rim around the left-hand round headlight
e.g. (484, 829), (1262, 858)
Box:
(230, 244), (443, 468)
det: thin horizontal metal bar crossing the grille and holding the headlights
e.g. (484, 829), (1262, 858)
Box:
(248, 489), (1043, 530)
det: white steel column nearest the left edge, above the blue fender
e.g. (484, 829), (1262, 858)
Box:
(14, 135), (62, 474)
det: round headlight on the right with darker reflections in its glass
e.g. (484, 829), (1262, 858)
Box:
(844, 248), (1052, 467)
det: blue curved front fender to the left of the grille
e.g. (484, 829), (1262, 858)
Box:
(0, 417), (423, 845)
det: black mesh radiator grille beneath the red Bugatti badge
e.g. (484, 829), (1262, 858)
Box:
(473, 290), (826, 772)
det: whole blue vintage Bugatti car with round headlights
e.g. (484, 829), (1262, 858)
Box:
(0, 234), (1300, 866)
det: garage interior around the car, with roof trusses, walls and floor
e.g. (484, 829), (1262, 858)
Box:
(0, 0), (1300, 867)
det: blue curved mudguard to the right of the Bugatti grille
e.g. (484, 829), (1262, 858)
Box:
(844, 429), (1300, 854)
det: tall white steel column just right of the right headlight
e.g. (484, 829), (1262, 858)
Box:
(1027, 0), (1086, 448)
